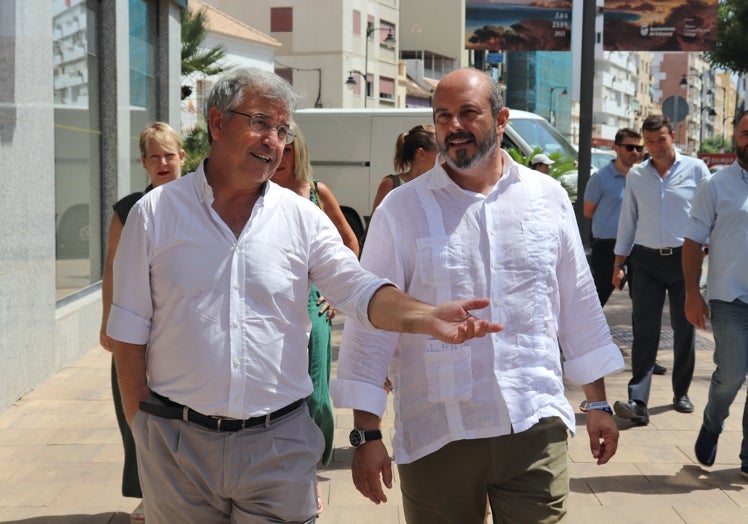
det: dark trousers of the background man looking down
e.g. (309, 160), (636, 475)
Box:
(628, 246), (695, 405)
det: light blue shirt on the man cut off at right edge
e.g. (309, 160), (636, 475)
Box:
(686, 162), (748, 303)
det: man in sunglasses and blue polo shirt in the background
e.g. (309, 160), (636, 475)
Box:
(584, 128), (643, 306)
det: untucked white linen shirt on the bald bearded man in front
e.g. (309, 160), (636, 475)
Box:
(331, 151), (623, 463)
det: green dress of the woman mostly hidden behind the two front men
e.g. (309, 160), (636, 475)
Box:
(307, 180), (335, 465)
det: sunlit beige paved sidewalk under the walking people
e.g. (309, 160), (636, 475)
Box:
(0, 292), (748, 524)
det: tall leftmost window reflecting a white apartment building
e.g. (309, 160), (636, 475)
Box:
(52, 2), (101, 298)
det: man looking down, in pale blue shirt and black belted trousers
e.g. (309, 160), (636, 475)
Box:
(613, 115), (709, 424)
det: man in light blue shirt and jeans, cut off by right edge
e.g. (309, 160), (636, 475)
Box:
(683, 111), (748, 477)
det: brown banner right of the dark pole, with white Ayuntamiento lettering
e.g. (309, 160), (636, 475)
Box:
(603, 0), (719, 51)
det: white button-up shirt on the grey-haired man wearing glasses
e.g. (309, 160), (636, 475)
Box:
(107, 165), (387, 419)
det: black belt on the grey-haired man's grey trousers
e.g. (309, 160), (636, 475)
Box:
(140, 393), (304, 431)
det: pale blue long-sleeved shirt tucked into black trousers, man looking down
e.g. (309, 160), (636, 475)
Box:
(614, 151), (709, 257)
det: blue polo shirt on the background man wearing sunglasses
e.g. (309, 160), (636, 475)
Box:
(584, 160), (626, 240)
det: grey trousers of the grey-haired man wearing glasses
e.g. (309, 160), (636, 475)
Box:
(132, 398), (324, 524)
